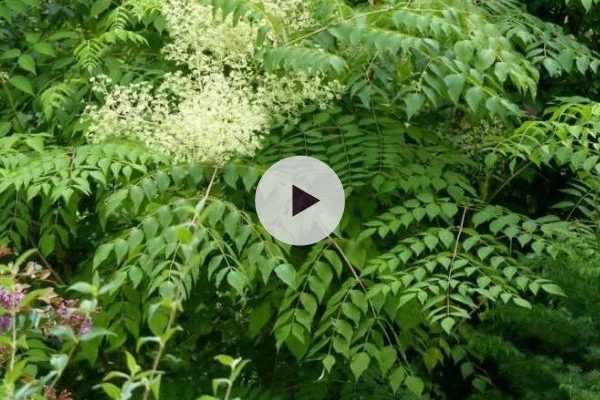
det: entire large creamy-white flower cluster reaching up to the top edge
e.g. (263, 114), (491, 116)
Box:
(85, 0), (342, 163)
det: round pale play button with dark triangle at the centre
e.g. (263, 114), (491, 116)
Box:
(255, 156), (345, 246)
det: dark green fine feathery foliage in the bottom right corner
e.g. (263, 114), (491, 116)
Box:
(467, 259), (599, 400)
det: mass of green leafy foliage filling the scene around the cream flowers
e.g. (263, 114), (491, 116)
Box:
(0, 0), (600, 400)
